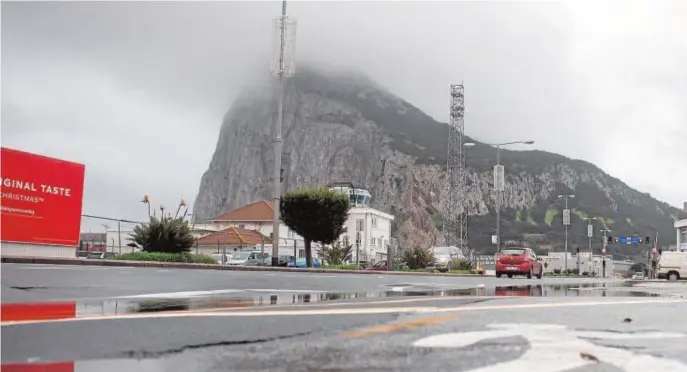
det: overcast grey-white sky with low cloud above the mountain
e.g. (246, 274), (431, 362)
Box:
(2, 0), (687, 230)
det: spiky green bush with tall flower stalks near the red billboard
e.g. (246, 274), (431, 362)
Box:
(129, 196), (194, 253)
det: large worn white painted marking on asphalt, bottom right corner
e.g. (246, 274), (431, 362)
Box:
(413, 324), (687, 372)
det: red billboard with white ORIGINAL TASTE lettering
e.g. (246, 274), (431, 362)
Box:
(0, 147), (86, 247)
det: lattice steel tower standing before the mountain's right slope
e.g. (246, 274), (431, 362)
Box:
(443, 83), (470, 257)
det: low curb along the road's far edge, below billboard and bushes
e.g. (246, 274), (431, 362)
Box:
(0, 256), (482, 277)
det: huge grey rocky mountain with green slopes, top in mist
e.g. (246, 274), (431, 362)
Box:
(193, 68), (680, 256)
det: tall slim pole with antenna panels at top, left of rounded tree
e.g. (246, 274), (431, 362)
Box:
(272, 0), (296, 266)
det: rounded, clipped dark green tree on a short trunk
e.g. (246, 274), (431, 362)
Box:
(280, 188), (351, 267)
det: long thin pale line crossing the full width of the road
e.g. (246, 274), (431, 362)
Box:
(0, 299), (687, 326)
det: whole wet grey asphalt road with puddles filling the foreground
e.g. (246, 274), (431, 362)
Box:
(2, 264), (687, 372)
